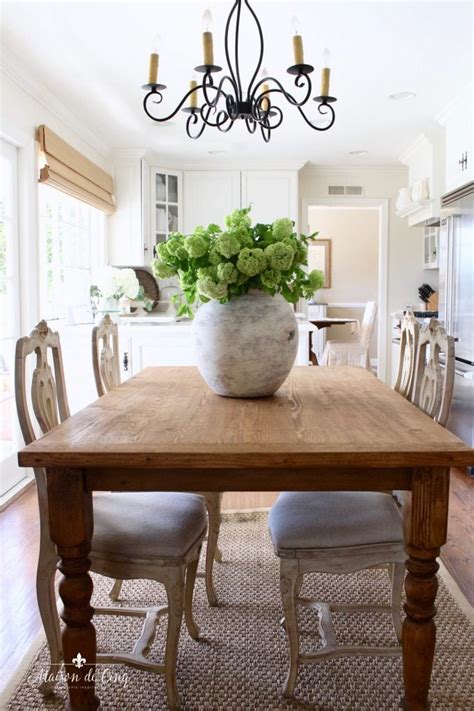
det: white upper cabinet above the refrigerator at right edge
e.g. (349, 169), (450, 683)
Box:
(439, 90), (474, 193)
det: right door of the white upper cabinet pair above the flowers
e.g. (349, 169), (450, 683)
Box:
(242, 170), (298, 226)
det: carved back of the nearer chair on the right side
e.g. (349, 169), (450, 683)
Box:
(412, 318), (455, 427)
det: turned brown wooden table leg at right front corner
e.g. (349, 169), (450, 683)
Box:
(402, 468), (449, 711)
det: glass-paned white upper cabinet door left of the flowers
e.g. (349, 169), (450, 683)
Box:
(151, 168), (183, 255)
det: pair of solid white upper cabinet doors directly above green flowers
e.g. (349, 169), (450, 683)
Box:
(184, 170), (298, 233)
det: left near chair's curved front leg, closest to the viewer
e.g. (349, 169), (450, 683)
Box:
(165, 566), (185, 711)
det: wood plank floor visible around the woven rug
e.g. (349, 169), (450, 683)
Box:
(0, 470), (474, 688)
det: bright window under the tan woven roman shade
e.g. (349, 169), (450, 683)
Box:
(39, 185), (106, 324)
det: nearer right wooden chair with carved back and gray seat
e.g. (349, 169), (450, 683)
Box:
(269, 319), (454, 698)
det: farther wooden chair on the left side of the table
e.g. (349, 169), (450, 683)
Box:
(92, 314), (222, 606)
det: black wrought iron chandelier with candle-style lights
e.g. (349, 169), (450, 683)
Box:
(142, 0), (337, 143)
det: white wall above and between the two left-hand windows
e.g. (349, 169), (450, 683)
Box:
(0, 64), (109, 333)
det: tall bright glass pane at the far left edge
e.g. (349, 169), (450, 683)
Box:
(0, 139), (22, 503)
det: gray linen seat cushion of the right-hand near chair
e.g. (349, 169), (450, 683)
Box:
(268, 491), (403, 553)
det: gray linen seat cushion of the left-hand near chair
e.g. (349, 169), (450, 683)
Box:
(92, 492), (207, 560)
